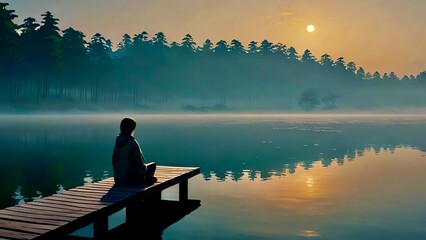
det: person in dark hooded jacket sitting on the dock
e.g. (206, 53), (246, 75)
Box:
(112, 118), (157, 185)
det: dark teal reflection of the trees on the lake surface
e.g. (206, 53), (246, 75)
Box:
(0, 116), (426, 210)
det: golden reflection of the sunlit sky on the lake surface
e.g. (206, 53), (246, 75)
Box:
(171, 147), (426, 240)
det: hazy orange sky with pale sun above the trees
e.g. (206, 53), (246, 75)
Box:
(4, 0), (426, 76)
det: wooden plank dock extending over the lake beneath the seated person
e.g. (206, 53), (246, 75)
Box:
(0, 166), (200, 240)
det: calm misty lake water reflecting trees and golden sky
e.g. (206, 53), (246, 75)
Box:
(0, 115), (426, 239)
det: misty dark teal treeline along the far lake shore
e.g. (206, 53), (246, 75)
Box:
(0, 3), (426, 109)
